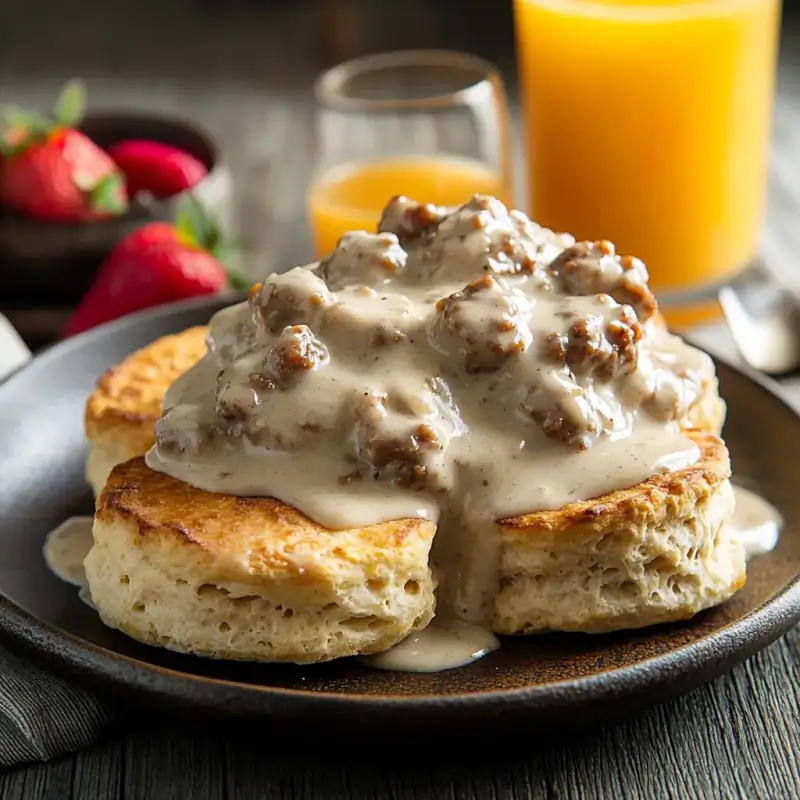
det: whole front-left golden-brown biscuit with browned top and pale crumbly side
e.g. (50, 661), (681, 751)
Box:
(85, 458), (435, 663)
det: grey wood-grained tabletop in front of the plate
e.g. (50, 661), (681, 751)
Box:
(0, 629), (800, 800)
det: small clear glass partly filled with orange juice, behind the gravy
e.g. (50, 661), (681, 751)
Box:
(308, 50), (512, 258)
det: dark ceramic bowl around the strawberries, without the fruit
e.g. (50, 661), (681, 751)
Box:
(0, 112), (231, 306)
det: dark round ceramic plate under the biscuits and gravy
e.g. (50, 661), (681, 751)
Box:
(0, 301), (800, 737)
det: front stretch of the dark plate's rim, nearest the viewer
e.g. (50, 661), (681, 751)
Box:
(0, 575), (800, 711)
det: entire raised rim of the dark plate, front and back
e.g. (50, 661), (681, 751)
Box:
(0, 295), (800, 713)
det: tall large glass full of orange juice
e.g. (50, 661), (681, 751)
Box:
(514, 0), (780, 324)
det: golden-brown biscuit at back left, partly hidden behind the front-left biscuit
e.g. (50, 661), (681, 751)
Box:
(84, 326), (208, 495)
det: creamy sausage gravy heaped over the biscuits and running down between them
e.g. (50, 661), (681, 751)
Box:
(147, 196), (714, 666)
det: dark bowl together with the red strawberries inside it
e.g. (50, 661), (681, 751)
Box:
(0, 81), (236, 307)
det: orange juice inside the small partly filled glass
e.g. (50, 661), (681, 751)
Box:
(308, 156), (508, 258)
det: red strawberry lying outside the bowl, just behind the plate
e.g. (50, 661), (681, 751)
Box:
(64, 195), (250, 336)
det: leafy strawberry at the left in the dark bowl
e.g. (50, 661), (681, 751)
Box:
(0, 81), (128, 222)
